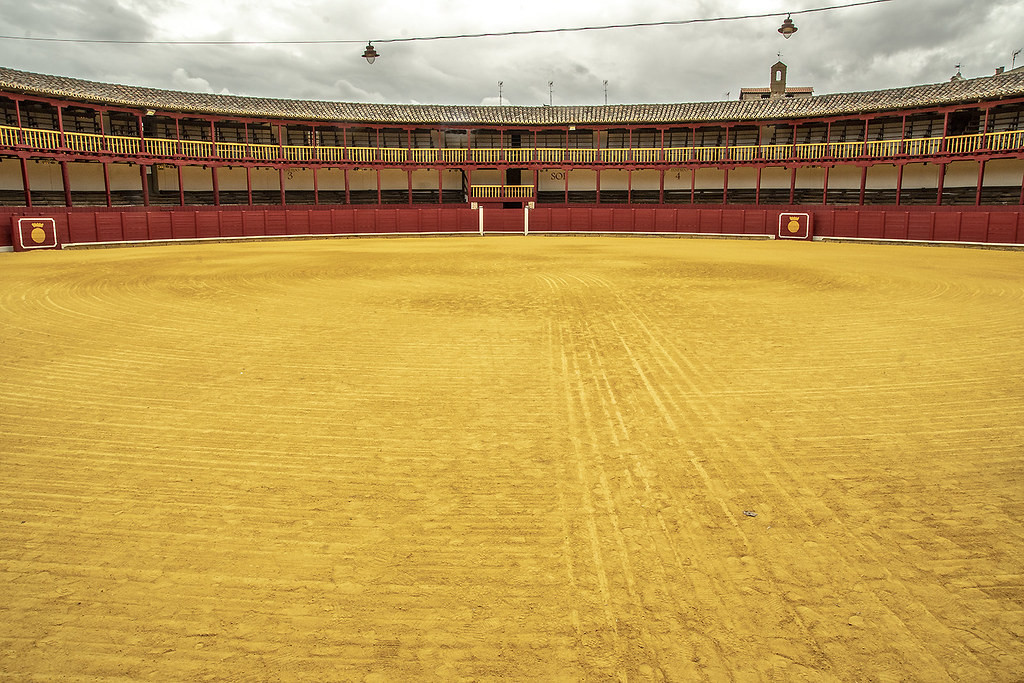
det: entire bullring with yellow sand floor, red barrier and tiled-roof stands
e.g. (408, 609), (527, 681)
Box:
(0, 46), (1024, 682)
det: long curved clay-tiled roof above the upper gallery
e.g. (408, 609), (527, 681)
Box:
(0, 68), (1024, 126)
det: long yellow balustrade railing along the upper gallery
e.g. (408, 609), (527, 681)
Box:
(0, 126), (1024, 166)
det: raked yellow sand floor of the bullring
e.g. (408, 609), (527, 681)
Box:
(0, 237), (1024, 681)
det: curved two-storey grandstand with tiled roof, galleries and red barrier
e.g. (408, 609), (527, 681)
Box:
(0, 68), (1024, 249)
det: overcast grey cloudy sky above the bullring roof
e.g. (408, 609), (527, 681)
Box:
(0, 0), (1024, 105)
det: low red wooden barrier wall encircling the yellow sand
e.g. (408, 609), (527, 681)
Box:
(0, 206), (1024, 251)
